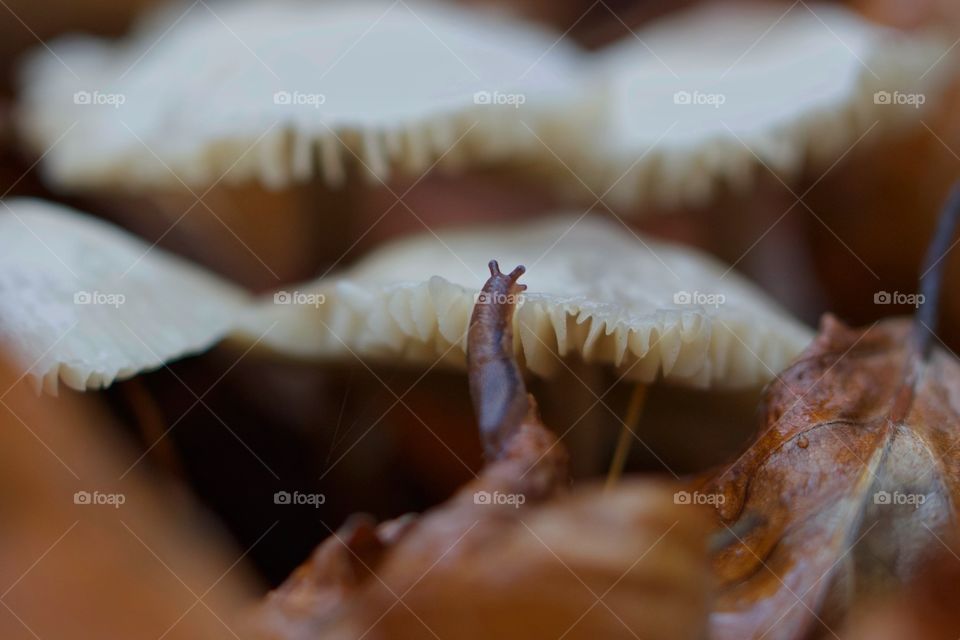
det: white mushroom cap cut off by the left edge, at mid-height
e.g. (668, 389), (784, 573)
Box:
(0, 199), (247, 393)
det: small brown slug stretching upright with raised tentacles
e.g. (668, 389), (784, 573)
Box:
(467, 260), (533, 460)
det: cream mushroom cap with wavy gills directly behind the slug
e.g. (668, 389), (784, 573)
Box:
(240, 215), (811, 388)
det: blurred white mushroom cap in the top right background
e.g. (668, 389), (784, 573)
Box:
(554, 3), (953, 207)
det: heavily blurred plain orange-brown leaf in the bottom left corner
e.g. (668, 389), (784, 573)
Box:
(0, 359), (256, 640)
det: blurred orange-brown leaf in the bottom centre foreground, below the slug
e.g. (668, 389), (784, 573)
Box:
(326, 482), (710, 640)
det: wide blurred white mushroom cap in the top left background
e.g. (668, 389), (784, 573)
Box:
(19, 0), (580, 187)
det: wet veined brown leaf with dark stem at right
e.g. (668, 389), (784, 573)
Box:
(704, 316), (960, 640)
